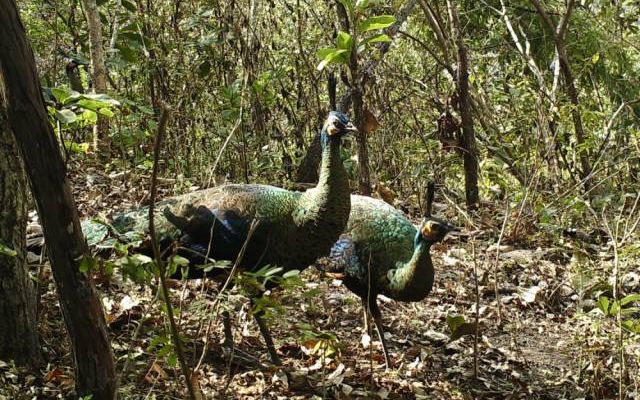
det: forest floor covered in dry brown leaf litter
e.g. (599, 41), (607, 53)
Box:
(0, 161), (640, 399)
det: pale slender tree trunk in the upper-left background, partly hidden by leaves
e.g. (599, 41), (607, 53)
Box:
(82, 0), (110, 152)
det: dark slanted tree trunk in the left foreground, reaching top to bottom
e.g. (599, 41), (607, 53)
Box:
(0, 0), (116, 400)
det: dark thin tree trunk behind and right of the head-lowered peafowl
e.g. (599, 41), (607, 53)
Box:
(447, 0), (480, 210)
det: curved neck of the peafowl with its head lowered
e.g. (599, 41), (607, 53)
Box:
(385, 232), (434, 301)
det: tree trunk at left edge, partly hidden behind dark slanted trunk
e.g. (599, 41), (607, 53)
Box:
(0, 87), (42, 369)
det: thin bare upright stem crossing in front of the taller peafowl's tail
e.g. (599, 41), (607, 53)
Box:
(149, 103), (200, 400)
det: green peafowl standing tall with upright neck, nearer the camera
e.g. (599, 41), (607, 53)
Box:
(35, 111), (356, 364)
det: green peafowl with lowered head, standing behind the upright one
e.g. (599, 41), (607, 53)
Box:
(317, 184), (456, 368)
